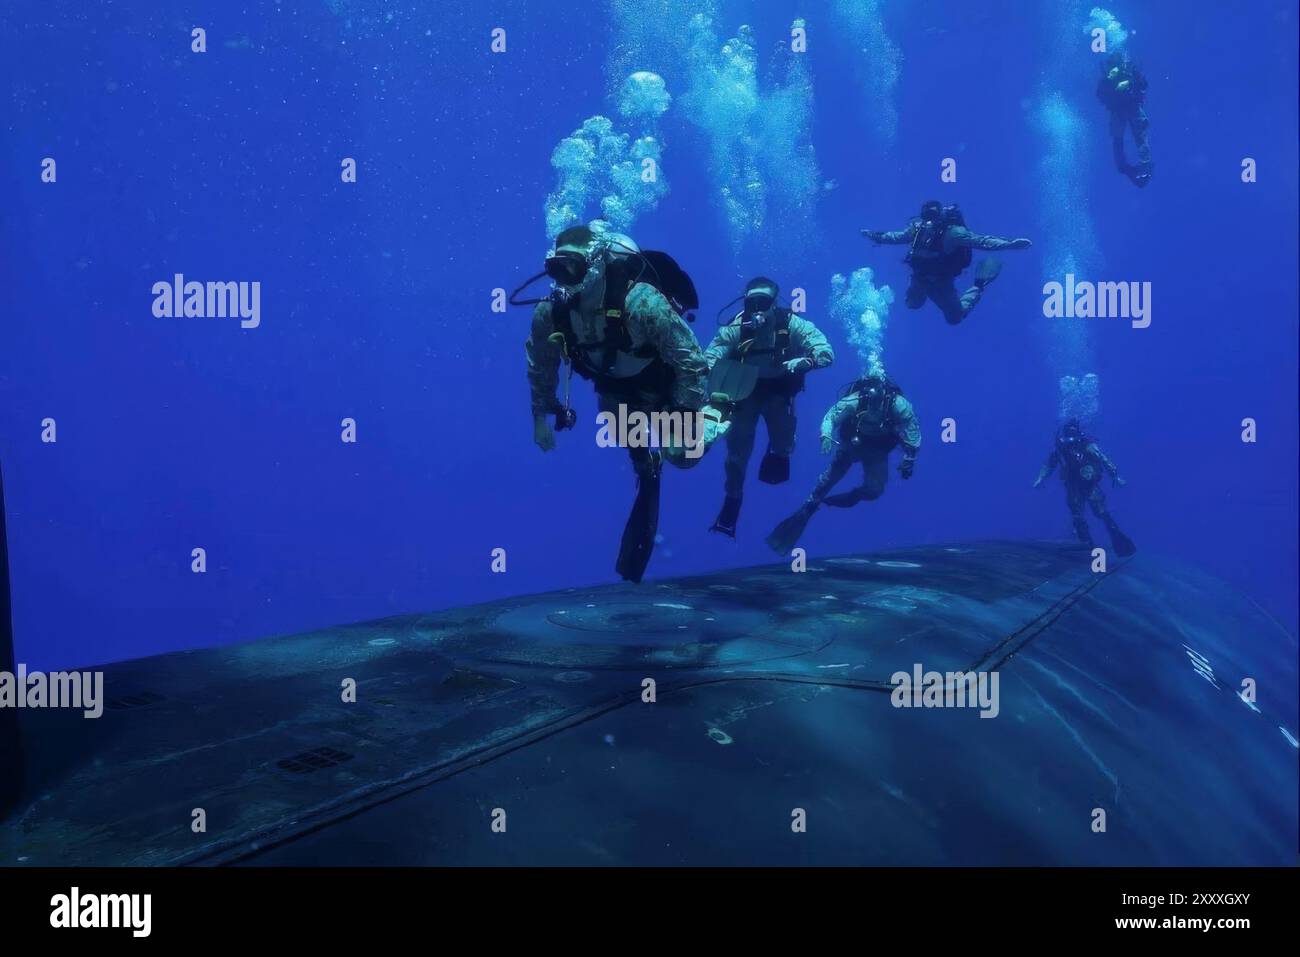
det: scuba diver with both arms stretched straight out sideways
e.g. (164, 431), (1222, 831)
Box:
(862, 199), (1031, 325)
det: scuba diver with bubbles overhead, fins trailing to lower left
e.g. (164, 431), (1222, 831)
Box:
(767, 374), (920, 555)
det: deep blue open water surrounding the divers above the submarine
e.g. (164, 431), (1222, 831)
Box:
(0, 0), (1300, 667)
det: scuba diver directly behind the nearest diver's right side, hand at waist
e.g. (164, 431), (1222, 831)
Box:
(705, 276), (835, 538)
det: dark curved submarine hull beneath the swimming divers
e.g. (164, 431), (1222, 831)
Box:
(0, 542), (1297, 866)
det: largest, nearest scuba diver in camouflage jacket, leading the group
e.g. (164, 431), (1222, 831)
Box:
(510, 221), (729, 581)
